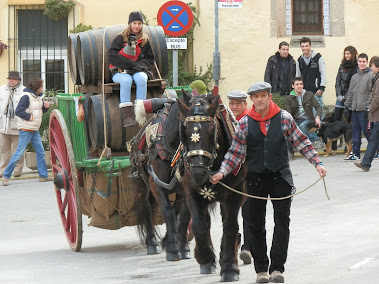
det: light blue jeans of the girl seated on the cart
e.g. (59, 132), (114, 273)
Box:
(112, 72), (148, 103)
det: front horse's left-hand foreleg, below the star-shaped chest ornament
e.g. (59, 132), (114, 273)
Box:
(187, 194), (216, 274)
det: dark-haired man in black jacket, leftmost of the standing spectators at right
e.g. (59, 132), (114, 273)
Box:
(264, 41), (296, 96)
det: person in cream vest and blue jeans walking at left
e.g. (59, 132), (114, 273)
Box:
(1, 78), (53, 186)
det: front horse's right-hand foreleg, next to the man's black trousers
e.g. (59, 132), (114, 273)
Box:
(220, 194), (242, 282)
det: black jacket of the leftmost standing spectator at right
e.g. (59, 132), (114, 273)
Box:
(264, 52), (296, 93)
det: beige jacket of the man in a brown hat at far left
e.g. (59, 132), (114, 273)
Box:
(0, 85), (25, 135)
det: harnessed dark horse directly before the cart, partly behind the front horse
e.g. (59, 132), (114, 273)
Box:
(130, 96), (191, 261)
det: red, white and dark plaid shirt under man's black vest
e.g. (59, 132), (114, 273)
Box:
(219, 110), (321, 177)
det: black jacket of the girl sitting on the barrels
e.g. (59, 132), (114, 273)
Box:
(108, 34), (154, 79)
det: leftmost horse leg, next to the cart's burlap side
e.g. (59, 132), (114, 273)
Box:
(132, 178), (161, 255)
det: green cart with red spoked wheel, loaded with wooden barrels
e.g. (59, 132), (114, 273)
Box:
(49, 26), (168, 251)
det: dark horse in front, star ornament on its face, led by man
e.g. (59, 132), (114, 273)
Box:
(178, 94), (246, 282)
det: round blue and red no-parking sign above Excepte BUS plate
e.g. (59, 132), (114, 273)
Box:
(157, 1), (193, 36)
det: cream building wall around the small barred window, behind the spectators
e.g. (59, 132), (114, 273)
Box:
(193, 0), (379, 105)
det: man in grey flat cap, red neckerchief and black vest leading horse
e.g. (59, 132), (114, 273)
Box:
(211, 82), (326, 283)
